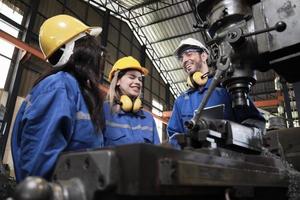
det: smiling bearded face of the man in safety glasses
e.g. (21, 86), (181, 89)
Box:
(180, 51), (208, 75)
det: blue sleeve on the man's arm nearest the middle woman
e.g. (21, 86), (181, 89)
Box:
(167, 101), (185, 149)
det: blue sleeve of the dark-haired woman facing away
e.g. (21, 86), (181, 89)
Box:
(20, 88), (76, 179)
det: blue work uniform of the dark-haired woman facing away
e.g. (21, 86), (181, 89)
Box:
(11, 72), (103, 182)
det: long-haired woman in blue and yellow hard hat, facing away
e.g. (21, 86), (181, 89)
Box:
(12, 15), (103, 182)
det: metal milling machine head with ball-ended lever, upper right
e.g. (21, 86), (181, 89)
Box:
(191, 0), (300, 106)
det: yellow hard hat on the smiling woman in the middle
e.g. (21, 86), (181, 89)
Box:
(108, 56), (148, 82)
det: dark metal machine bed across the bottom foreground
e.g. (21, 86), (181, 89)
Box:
(14, 144), (300, 200)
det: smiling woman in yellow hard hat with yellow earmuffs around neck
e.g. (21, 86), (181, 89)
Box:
(103, 56), (160, 146)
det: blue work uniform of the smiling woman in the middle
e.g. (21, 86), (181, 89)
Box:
(102, 101), (160, 147)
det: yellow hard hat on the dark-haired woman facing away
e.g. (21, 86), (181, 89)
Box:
(39, 15), (102, 59)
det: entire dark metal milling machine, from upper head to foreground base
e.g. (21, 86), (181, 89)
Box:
(8, 0), (300, 200)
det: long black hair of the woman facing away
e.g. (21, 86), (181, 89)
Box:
(34, 34), (105, 131)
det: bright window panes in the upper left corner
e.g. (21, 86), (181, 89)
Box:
(0, 2), (23, 88)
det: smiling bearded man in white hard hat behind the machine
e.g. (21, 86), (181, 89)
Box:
(167, 38), (265, 148)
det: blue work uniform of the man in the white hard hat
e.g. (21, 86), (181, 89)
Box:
(167, 79), (265, 148)
